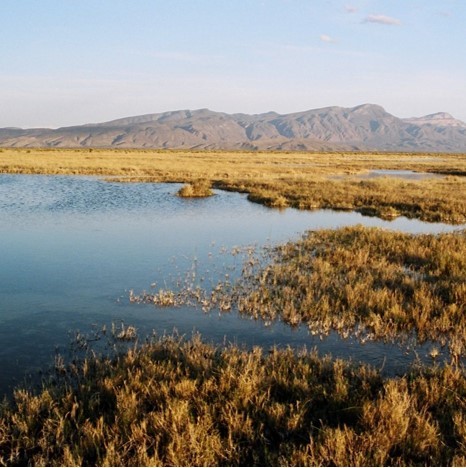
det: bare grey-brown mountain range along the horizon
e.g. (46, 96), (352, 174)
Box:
(0, 104), (466, 153)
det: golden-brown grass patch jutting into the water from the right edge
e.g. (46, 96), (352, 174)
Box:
(238, 226), (466, 355)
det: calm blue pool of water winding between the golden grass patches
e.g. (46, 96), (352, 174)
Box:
(0, 175), (457, 394)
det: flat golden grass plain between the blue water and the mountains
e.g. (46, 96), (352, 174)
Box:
(0, 148), (466, 224)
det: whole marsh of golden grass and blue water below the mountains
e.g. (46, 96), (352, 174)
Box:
(0, 149), (466, 465)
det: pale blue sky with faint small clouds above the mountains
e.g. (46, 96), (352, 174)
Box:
(0, 0), (466, 128)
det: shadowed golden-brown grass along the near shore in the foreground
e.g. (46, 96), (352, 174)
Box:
(0, 336), (466, 466)
